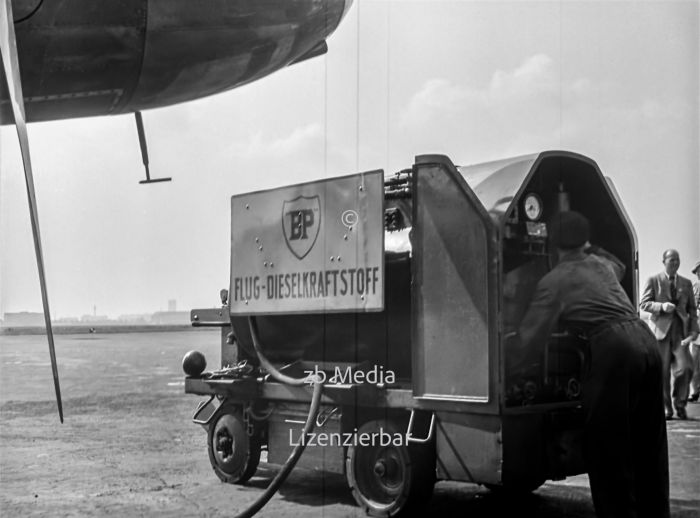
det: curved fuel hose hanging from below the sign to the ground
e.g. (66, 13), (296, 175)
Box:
(236, 317), (323, 518)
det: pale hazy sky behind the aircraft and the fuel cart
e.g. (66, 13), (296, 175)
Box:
(0, 0), (700, 318)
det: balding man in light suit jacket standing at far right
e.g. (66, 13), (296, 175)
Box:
(639, 249), (698, 419)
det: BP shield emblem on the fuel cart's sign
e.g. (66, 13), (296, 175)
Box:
(282, 195), (321, 259)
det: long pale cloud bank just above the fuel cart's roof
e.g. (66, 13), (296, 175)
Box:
(398, 54), (692, 163)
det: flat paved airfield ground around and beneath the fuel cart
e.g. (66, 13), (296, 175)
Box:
(0, 330), (700, 518)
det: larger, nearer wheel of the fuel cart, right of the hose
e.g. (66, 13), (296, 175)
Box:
(345, 420), (435, 517)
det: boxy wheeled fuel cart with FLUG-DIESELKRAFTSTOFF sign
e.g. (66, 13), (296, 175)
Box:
(183, 151), (637, 516)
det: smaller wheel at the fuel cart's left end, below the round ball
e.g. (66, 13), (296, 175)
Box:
(207, 407), (260, 484)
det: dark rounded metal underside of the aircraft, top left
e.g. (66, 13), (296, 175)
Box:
(0, 0), (352, 124)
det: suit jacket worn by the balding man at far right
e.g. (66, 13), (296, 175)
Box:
(639, 272), (698, 340)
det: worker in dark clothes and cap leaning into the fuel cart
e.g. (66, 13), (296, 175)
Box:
(516, 211), (669, 518)
